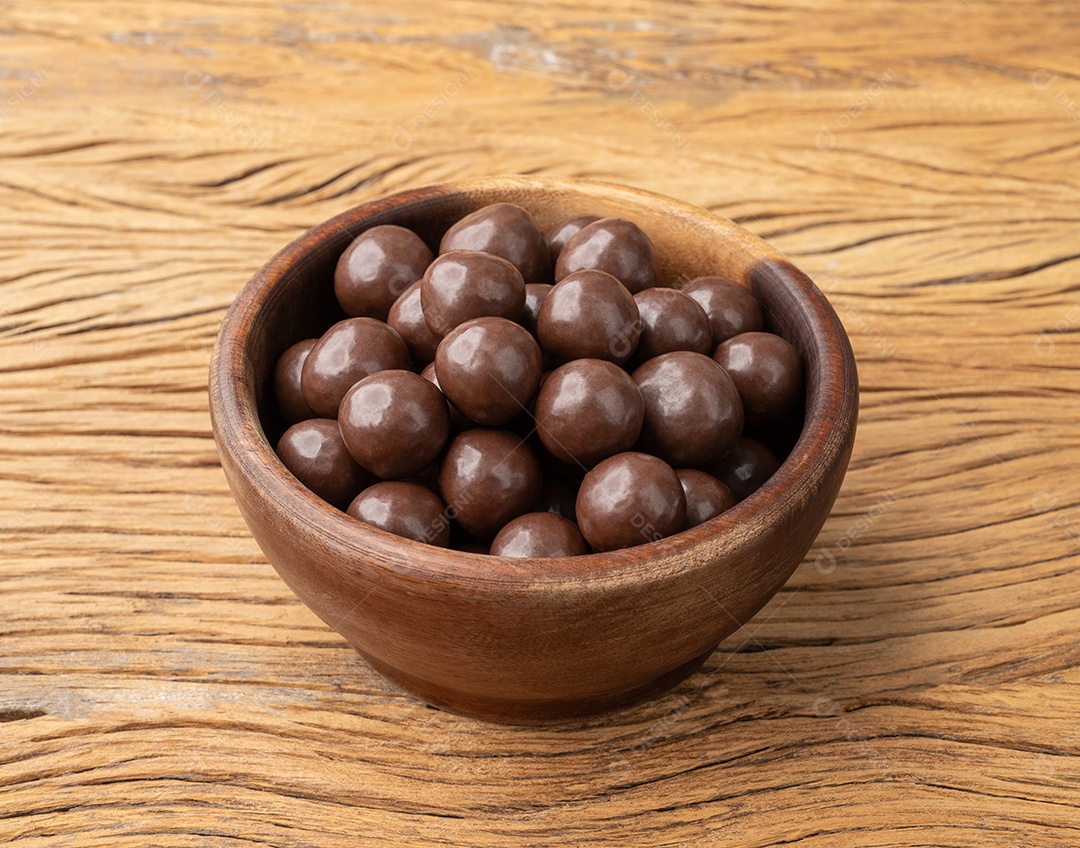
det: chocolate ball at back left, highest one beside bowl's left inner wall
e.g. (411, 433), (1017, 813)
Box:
(334, 224), (435, 321)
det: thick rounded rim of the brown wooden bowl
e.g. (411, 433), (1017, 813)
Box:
(210, 175), (858, 588)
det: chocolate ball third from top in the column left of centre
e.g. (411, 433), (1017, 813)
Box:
(435, 318), (542, 427)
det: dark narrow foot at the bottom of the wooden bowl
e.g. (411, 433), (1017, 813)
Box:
(353, 645), (715, 725)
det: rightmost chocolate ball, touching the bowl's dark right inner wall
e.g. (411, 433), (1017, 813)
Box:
(713, 333), (802, 428)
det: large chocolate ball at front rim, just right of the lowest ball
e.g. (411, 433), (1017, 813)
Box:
(577, 452), (686, 551)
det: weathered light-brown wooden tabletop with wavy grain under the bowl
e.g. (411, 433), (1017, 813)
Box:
(0, 0), (1080, 848)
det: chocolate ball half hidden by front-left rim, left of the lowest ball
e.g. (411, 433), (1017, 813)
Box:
(346, 480), (450, 548)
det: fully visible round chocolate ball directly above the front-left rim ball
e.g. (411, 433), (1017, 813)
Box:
(338, 371), (450, 480)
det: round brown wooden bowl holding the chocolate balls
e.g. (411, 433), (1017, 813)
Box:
(210, 176), (859, 723)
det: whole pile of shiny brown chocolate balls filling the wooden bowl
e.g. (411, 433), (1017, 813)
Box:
(273, 203), (804, 557)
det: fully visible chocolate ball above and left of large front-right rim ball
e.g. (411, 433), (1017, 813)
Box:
(536, 360), (645, 468)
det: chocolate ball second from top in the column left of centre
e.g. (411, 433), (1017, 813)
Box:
(420, 251), (525, 338)
